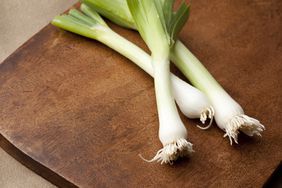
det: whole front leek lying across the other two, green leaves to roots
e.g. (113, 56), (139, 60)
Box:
(127, 0), (192, 163)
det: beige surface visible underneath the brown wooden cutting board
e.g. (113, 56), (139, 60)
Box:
(0, 0), (74, 188)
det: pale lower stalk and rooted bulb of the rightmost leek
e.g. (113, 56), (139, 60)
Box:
(171, 41), (265, 144)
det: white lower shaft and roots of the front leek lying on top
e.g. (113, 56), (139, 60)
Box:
(139, 61), (193, 164)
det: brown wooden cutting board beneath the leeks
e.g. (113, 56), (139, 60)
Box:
(0, 0), (282, 187)
